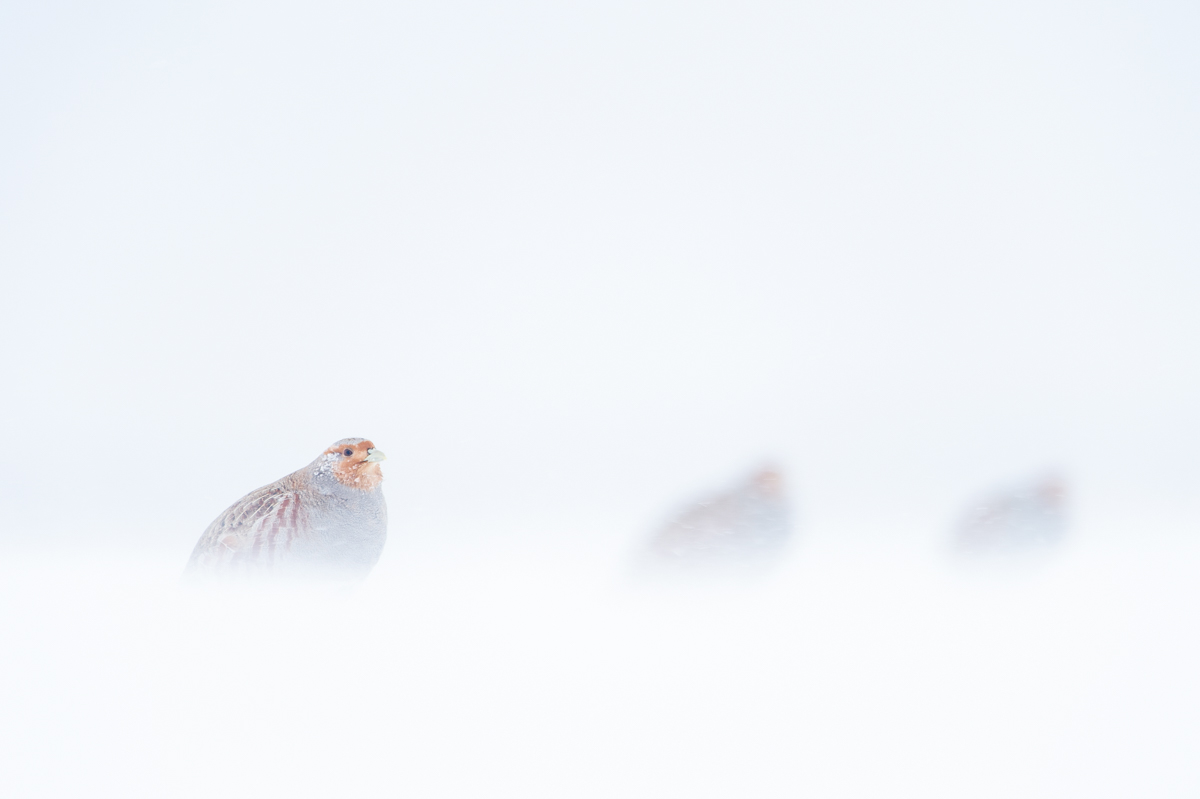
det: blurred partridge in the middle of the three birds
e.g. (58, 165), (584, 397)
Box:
(647, 467), (791, 564)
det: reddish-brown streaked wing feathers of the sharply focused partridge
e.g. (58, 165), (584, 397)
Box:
(187, 486), (306, 571)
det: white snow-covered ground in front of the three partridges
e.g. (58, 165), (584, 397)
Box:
(0, 535), (1200, 799)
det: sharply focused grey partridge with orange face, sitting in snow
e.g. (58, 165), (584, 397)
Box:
(187, 438), (388, 579)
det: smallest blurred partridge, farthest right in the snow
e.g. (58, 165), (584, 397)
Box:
(953, 475), (1067, 553)
